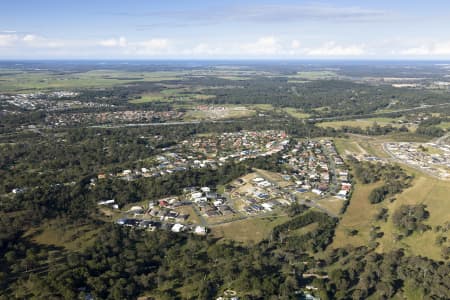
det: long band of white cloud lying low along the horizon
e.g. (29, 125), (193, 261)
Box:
(7, 31), (450, 58)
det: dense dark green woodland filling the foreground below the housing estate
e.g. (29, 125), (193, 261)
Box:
(0, 212), (450, 299)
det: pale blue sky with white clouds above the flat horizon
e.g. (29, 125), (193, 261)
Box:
(0, 0), (450, 60)
